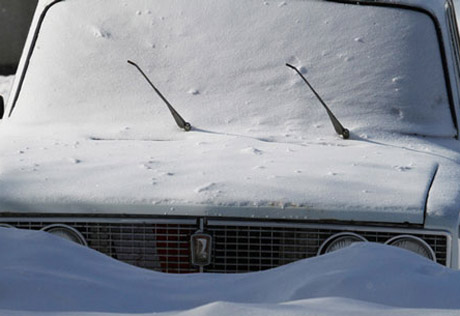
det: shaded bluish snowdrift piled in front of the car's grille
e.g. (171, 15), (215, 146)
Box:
(0, 228), (460, 315)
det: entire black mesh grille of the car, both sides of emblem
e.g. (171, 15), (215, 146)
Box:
(2, 218), (447, 273)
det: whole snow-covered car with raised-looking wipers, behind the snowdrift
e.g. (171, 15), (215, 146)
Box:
(0, 0), (460, 273)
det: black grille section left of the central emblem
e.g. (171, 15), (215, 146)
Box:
(8, 222), (198, 273)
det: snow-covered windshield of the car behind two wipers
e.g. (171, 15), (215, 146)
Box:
(8, 0), (456, 141)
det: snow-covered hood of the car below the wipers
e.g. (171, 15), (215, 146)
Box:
(0, 131), (444, 224)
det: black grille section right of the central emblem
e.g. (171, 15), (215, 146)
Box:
(205, 225), (447, 273)
